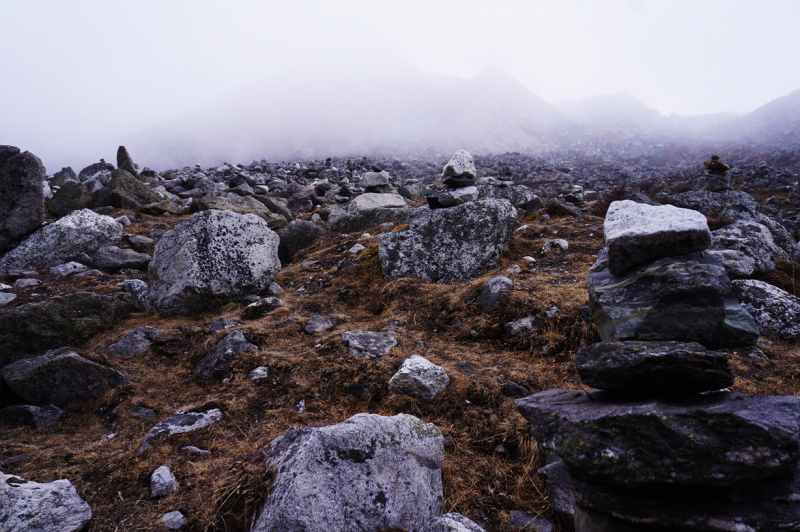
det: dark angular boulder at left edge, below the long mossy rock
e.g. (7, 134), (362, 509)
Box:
(0, 348), (130, 410)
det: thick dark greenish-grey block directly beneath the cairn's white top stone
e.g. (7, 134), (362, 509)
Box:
(587, 250), (758, 348)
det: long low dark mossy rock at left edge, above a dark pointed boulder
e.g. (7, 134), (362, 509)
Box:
(0, 292), (133, 367)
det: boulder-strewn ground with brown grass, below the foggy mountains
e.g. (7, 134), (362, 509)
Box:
(0, 142), (800, 532)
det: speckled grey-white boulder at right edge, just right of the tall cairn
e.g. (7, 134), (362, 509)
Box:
(733, 279), (800, 344)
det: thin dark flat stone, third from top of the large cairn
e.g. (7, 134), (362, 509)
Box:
(575, 341), (733, 393)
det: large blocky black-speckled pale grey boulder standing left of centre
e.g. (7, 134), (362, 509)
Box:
(149, 211), (281, 314)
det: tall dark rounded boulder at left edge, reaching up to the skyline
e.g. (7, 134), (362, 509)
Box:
(0, 146), (45, 253)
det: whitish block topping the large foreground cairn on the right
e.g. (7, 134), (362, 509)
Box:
(603, 200), (711, 275)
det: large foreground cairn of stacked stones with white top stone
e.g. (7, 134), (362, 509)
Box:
(517, 201), (800, 532)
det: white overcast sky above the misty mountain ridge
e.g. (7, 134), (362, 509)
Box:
(0, 0), (800, 171)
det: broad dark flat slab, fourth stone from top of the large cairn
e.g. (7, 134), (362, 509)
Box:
(516, 389), (800, 487)
